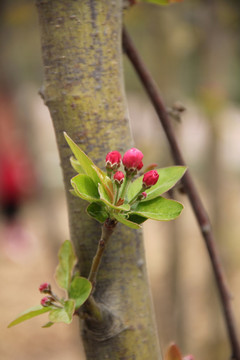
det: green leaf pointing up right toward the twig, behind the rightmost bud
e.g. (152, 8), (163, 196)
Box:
(128, 166), (187, 201)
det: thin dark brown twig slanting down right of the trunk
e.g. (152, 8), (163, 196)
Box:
(122, 29), (240, 360)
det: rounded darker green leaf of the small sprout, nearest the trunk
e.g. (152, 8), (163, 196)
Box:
(69, 277), (92, 309)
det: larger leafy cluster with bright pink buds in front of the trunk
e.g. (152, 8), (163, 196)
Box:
(64, 133), (186, 229)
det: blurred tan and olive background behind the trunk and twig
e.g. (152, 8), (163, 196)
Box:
(0, 0), (240, 360)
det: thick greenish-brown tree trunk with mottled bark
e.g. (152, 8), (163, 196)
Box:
(37, 0), (161, 360)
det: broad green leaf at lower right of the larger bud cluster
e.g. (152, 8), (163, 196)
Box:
(131, 196), (183, 221)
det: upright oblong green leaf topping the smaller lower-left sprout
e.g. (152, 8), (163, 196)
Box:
(55, 240), (76, 290)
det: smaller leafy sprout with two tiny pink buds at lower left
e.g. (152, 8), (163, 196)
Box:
(8, 240), (92, 328)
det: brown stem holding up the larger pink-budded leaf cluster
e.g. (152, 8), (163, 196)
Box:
(88, 218), (117, 288)
